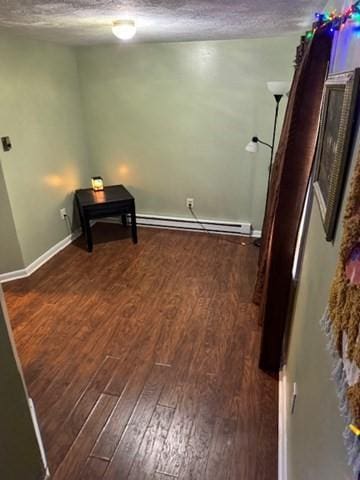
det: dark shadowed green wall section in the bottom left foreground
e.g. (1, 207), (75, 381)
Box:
(0, 286), (44, 480)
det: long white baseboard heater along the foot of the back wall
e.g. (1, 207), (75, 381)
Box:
(98, 214), (257, 236)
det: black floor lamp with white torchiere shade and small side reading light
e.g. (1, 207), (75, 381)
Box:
(245, 82), (290, 247)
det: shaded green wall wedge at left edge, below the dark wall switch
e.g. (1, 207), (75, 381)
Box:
(0, 164), (24, 273)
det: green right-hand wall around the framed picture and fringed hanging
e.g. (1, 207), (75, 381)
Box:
(287, 9), (360, 480)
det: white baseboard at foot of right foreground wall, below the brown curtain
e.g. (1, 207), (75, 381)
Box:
(278, 366), (288, 480)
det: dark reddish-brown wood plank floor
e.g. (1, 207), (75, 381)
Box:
(5, 224), (278, 480)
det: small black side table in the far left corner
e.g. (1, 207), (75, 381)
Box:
(75, 185), (137, 252)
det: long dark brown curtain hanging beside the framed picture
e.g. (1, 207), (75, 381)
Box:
(254, 31), (332, 371)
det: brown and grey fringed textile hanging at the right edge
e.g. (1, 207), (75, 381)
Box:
(321, 154), (360, 479)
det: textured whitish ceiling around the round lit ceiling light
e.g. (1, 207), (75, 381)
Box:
(0, 0), (326, 45)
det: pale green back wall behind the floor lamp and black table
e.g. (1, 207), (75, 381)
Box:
(78, 36), (298, 229)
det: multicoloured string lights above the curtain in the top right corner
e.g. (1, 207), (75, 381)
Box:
(305, 0), (360, 40)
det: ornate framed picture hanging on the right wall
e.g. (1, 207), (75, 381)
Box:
(314, 69), (360, 241)
